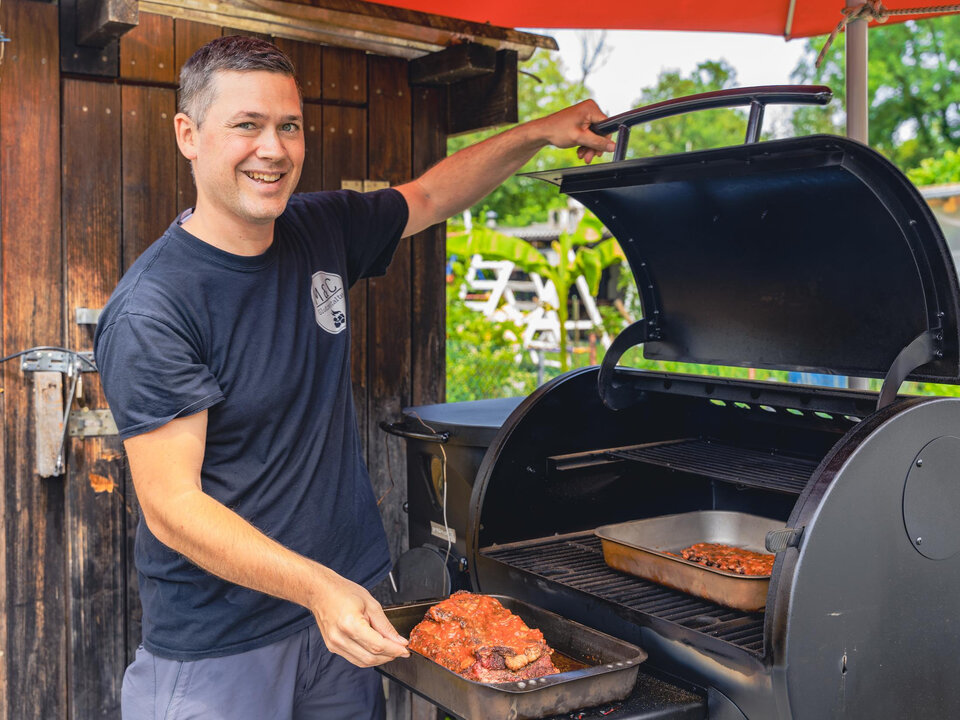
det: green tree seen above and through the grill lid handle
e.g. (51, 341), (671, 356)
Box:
(630, 60), (747, 157)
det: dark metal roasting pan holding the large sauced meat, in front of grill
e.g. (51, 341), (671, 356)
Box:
(377, 595), (647, 720)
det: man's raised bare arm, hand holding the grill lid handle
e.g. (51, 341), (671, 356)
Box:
(397, 100), (615, 237)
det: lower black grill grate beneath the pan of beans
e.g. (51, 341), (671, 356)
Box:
(483, 534), (763, 655)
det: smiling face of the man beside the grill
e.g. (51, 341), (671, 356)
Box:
(181, 70), (304, 224)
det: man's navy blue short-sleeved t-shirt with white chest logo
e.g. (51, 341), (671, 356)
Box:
(94, 189), (407, 660)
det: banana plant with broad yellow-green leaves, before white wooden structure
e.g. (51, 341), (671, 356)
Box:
(447, 215), (624, 372)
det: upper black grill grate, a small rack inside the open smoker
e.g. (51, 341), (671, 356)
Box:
(608, 439), (818, 495)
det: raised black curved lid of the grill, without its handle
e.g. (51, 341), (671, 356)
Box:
(532, 128), (960, 394)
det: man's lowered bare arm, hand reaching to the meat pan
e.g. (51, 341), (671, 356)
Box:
(124, 411), (409, 667)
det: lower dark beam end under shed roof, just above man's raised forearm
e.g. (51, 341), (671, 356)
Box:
(447, 50), (518, 135)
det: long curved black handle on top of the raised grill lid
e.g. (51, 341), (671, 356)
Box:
(590, 85), (833, 162)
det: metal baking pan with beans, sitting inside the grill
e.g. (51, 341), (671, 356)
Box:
(594, 510), (784, 612)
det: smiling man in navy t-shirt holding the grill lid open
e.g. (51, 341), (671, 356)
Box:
(95, 37), (613, 720)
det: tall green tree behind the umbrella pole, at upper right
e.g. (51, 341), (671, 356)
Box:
(793, 15), (960, 170)
